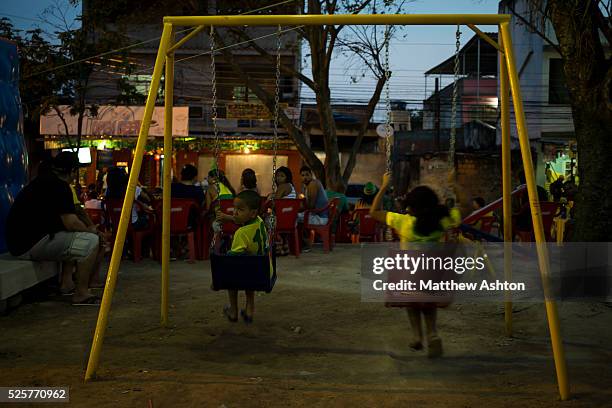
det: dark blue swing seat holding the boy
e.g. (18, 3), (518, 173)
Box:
(210, 252), (276, 293)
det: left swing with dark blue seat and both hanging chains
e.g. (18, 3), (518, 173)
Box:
(210, 26), (281, 293)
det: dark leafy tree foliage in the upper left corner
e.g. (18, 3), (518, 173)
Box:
(0, 0), (132, 147)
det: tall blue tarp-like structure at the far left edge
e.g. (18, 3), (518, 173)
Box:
(0, 39), (28, 253)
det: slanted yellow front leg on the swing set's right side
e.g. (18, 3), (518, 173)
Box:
(500, 23), (570, 400)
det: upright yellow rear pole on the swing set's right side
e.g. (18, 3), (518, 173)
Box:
(499, 32), (512, 337)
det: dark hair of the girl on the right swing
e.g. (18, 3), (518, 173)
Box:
(405, 186), (449, 236)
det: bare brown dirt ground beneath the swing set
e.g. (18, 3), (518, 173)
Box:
(0, 246), (612, 408)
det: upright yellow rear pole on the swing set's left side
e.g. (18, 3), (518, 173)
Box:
(161, 30), (174, 327)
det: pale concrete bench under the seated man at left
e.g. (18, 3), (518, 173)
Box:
(0, 253), (61, 311)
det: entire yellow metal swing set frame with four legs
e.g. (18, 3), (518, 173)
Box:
(85, 14), (570, 400)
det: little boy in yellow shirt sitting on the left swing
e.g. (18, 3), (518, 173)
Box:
(217, 190), (268, 324)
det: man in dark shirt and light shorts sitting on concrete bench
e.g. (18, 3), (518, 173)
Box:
(6, 152), (100, 304)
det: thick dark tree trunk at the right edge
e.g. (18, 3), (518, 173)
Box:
(548, 0), (612, 242)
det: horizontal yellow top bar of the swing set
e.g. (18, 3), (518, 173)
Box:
(164, 14), (510, 27)
